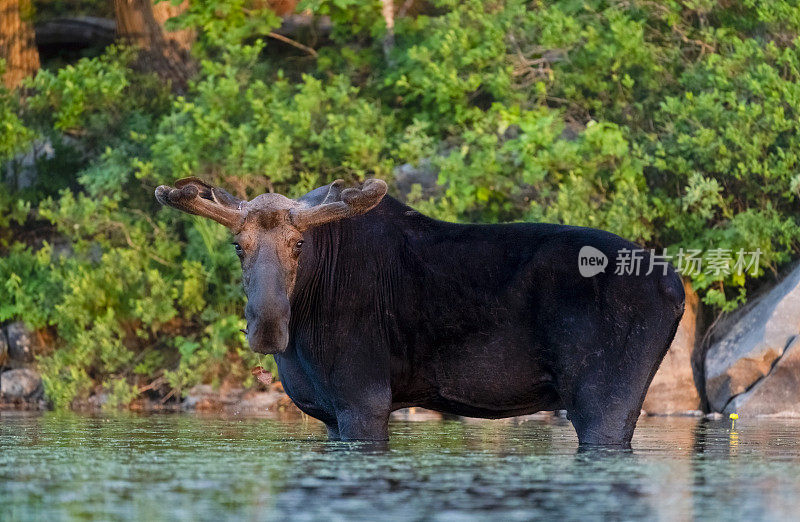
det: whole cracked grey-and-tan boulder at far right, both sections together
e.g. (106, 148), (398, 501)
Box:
(705, 267), (800, 414)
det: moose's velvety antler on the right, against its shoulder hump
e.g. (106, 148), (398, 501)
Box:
(289, 179), (387, 230)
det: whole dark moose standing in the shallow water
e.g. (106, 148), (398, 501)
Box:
(155, 177), (684, 447)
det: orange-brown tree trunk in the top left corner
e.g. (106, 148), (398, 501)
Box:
(0, 0), (39, 89)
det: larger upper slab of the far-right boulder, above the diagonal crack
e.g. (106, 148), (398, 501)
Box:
(705, 267), (800, 411)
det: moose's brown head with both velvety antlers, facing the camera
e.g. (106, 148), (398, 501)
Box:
(156, 177), (387, 353)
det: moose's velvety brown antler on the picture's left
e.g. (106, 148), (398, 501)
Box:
(156, 177), (245, 228)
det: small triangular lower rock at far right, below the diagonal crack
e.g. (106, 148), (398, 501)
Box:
(725, 336), (800, 417)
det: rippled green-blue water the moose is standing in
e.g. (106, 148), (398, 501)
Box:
(0, 413), (800, 521)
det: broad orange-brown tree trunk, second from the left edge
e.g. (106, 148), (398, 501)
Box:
(114, 0), (196, 90)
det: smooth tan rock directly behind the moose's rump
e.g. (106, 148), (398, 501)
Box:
(642, 283), (700, 415)
